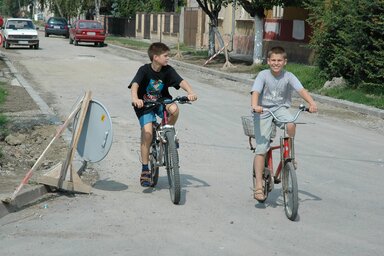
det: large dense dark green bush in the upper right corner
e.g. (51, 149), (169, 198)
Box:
(307, 0), (384, 95)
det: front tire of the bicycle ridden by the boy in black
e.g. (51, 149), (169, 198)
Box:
(165, 129), (181, 204)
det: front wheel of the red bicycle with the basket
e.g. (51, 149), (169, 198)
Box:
(282, 161), (299, 221)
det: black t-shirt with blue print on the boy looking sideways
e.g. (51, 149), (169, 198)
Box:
(128, 64), (183, 116)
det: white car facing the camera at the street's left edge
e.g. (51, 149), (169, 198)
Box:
(2, 18), (39, 49)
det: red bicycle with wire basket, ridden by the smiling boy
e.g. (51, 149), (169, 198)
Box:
(241, 104), (309, 220)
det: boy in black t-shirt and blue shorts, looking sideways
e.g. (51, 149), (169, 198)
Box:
(128, 42), (197, 187)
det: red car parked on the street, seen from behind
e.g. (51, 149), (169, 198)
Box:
(69, 20), (106, 47)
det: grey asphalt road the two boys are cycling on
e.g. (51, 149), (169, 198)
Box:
(0, 32), (384, 256)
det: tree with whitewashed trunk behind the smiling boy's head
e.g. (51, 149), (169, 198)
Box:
(236, 0), (302, 64)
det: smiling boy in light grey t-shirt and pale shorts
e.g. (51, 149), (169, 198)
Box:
(251, 47), (317, 201)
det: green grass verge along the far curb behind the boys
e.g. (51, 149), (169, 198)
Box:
(103, 36), (384, 109)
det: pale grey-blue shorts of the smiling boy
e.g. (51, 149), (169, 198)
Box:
(253, 108), (293, 155)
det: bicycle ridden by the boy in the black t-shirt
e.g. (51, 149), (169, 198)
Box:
(144, 96), (190, 204)
